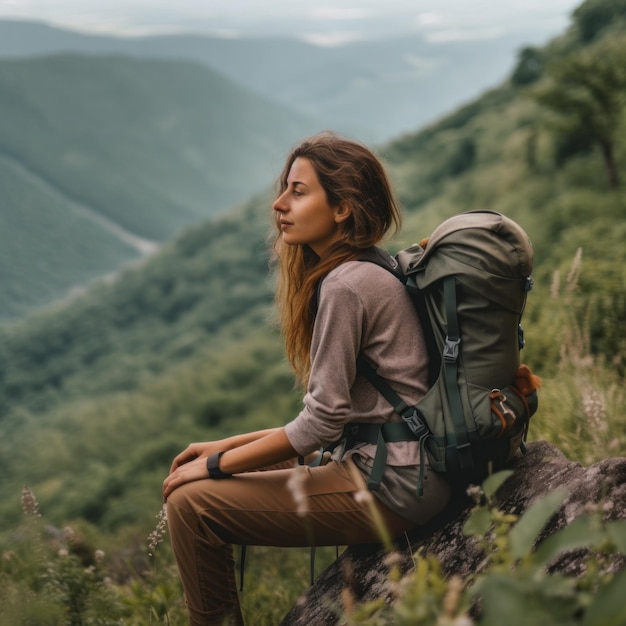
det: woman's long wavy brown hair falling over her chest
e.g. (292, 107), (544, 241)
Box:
(273, 133), (401, 386)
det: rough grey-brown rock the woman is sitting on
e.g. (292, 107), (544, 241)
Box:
(281, 441), (626, 626)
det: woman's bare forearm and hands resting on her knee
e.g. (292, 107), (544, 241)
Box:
(163, 428), (298, 500)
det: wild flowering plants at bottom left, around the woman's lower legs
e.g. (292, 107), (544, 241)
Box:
(0, 487), (336, 626)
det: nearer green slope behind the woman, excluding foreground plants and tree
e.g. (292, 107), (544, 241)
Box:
(0, 0), (626, 556)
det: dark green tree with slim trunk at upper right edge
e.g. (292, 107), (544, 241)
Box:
(531, 35), (626, 189)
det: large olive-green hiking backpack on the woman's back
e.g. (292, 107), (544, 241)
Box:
(355, 211), (541, 494)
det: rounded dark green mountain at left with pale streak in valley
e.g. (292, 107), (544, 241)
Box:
(0, 54), (314, 319)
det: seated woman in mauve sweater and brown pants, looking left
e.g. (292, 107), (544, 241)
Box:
(163, 134), (450, 625)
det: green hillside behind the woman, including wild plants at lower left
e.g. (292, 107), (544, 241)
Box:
(0, 0), (626, 626)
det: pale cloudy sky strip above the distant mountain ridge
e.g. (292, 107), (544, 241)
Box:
(0, 0), (582, 45)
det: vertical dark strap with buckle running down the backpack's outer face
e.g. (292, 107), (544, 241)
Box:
(442, 276), (474, 469)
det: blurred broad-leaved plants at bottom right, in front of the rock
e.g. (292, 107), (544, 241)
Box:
(343, 471), (626, 626)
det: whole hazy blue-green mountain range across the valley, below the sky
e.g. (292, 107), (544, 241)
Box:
(0, 20), (560, 321)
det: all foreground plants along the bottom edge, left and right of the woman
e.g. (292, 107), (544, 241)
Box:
(0, 471), (626, 626)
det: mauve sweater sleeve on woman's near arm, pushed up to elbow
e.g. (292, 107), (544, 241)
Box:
(285, 268), (367, 455)
